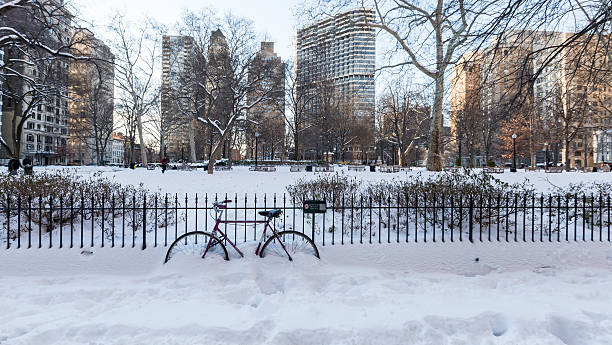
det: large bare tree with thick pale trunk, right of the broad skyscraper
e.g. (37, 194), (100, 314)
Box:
(302, 0), (496, 171)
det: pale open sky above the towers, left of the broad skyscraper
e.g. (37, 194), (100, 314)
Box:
(71, 0), (300, 59)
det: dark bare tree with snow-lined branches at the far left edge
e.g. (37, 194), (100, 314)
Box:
(0, 0), (87, 158)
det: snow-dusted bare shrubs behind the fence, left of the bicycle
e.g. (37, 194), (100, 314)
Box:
(0, 169), (178, 237)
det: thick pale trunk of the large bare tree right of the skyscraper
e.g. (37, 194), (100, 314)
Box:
(427, 72), (444, 171)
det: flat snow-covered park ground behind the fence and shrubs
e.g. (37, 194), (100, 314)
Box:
(37, 166), (612, 196)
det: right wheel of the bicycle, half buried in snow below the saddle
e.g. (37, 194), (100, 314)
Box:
(259, 231), (320, 260)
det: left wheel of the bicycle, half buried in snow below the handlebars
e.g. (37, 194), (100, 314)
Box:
(164, 231), (229, 263)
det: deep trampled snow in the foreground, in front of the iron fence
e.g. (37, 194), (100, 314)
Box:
(0, 243), (612, 345)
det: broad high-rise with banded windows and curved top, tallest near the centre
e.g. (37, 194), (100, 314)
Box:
(294, 9), (376, 159)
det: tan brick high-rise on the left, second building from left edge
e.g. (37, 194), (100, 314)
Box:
(68, 29), (115, 165)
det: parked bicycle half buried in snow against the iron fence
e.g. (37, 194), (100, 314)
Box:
(164, 200), (320, 263)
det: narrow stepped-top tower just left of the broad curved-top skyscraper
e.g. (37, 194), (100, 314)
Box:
(246, 42), (287, 159)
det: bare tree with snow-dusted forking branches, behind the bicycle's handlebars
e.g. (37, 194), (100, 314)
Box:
(176, 15), (274, 174)
